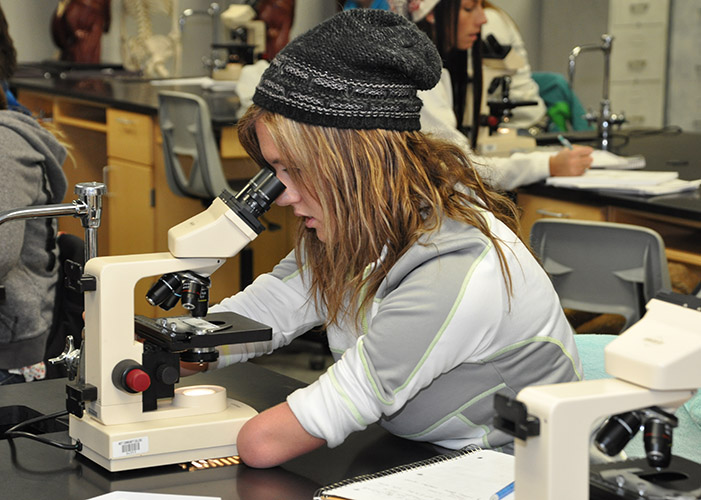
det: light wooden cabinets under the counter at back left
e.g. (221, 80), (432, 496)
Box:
(19, 90), (294, 317)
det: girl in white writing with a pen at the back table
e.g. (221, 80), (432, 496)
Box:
(408, 0), (593, 190)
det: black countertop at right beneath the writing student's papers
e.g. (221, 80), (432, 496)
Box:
(519, 128), (701, 221)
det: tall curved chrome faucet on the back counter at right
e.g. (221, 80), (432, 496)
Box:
(567, 34), (626, 151)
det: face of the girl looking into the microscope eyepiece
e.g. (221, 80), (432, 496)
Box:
(256, 121), (326, 241)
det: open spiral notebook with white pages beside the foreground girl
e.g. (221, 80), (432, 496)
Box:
(314, 446), (514, 500)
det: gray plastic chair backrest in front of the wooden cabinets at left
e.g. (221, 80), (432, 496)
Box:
(158, 90), (229, 201)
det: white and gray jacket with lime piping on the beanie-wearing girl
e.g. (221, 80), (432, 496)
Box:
(210, 212), (581, 450)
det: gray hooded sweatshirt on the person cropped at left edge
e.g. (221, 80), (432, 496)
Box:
(0, 111), (67, 370)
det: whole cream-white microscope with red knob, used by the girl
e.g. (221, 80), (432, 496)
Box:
(67, 169), (284, 471)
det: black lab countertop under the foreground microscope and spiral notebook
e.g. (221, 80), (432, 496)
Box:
(0, 363), (442, 500)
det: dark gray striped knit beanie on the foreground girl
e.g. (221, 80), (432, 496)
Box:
(253, 9), (441, 130)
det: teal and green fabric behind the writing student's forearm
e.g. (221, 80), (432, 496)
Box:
(532, 71), (593, 132)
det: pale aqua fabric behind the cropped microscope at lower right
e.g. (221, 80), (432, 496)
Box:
(575, 334), (701, 463)
